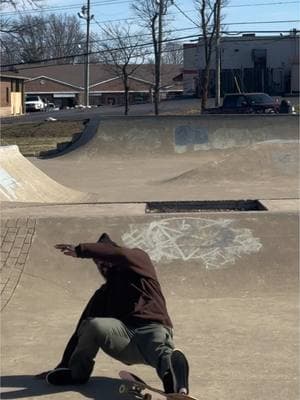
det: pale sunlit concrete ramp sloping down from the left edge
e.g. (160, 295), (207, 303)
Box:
(0, 146), (90, 203)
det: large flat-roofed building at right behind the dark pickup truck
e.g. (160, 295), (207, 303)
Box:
(183, 31), (299, 96)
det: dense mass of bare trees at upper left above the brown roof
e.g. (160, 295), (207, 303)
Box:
(1, 14), (85, 65)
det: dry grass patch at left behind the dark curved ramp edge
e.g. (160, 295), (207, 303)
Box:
(0, 120), (86, 156)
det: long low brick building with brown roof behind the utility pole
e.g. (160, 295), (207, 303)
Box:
(10, 64), (183, 108)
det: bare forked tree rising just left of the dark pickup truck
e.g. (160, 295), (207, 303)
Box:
(195, 0), (227, 111)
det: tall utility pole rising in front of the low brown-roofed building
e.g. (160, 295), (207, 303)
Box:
(77, 0), (94, 107)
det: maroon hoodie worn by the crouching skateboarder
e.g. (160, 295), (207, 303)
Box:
(76, 243), (172, 327)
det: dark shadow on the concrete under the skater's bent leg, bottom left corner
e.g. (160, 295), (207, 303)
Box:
(1, 375), (132, 400)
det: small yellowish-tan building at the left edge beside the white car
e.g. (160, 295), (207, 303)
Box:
(0, 72), (26, 117)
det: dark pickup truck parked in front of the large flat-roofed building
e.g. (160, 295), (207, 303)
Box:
(205, 93), (294, 114)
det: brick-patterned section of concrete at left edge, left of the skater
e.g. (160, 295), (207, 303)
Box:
(0, 218), (36, 311)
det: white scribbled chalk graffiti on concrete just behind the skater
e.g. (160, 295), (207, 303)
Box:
(122, 217), (262, 270)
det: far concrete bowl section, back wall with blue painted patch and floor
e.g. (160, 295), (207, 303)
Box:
(33, 115), (299, 202)
